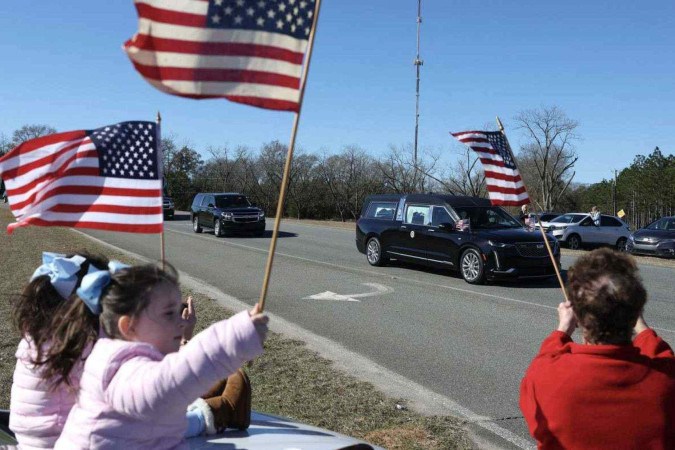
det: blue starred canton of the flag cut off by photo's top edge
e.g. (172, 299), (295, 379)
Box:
(207, 0), (315, 39)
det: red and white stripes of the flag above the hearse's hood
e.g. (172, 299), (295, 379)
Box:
(451, 131), (530, 206)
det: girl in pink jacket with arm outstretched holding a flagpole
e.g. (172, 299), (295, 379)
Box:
(55, 266), (267, 450)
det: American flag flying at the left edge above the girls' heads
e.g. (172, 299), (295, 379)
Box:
(0, 122), (163, 234)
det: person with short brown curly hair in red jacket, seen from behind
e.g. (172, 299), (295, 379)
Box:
(520, 249), (675, 449)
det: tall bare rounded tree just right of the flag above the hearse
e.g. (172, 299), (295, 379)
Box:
(515, 106), (580, 211)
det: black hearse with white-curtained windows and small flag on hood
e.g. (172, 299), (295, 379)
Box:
(356, 194), (560, 284)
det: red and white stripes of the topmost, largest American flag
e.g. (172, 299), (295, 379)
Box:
(124, 0), (307, 111)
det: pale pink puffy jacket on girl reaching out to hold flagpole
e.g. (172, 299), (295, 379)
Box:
(55, 311), (263, 450)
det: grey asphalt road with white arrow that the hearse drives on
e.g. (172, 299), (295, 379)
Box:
(80, 216), (675, 444)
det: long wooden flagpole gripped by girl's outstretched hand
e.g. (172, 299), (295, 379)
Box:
(258, 0), (321, 311)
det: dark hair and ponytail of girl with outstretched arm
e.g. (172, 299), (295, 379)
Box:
(41, 263), (178, 386)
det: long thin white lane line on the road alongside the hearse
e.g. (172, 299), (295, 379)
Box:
(168, 229), (675, 334)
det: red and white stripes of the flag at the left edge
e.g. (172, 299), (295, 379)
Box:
(0, 131), (163, 234)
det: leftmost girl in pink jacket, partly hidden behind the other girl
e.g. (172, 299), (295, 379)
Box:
(9, 252), (108, 449)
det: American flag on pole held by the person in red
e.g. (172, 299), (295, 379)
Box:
(451, 131), (530, 206)
